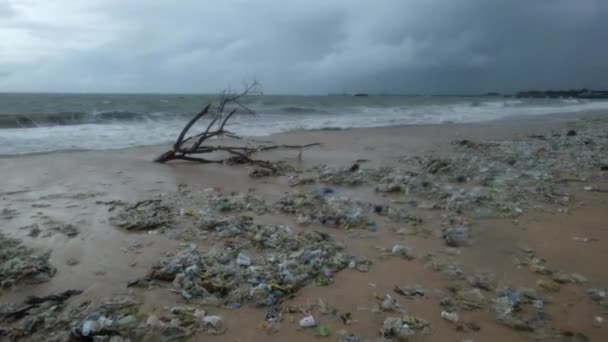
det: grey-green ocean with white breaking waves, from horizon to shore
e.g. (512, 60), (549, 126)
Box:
(0, 94), (608, 156)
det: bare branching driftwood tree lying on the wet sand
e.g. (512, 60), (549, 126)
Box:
(154, 81), (320, 173)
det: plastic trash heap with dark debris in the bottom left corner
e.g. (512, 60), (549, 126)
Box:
(0, 290), (226, 342)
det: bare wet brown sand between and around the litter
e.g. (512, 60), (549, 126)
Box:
(0, 114), (608, 341)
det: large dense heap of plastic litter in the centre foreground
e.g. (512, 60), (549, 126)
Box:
(147, 226), (350, 307)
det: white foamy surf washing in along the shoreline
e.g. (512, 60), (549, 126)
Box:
(0, 99), (608, 155)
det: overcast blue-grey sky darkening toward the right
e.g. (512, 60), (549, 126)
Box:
(0, 0), (608, 94)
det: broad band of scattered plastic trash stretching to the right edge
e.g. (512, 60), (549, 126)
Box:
(292, 125), (608, 217)
